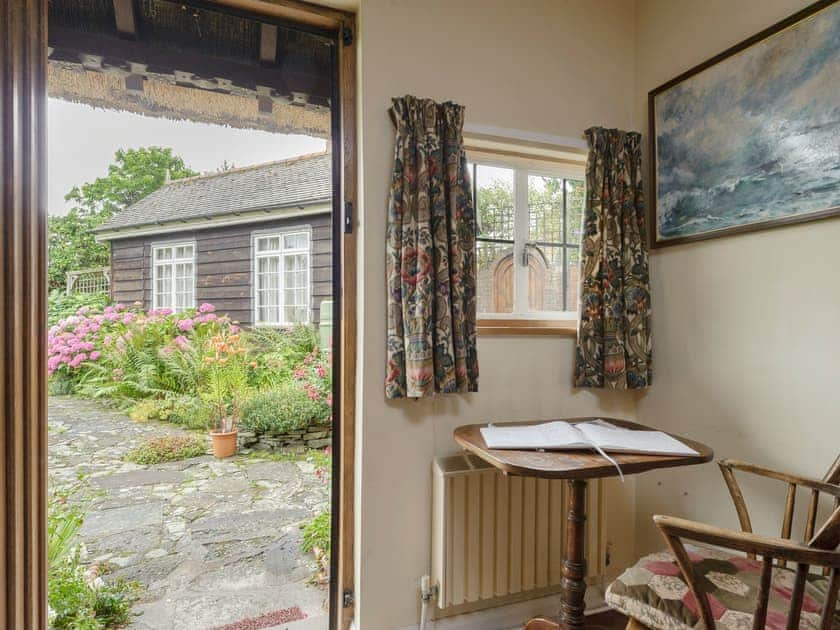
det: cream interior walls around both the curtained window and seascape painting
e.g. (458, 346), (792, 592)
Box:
(348, 0), (840, 630)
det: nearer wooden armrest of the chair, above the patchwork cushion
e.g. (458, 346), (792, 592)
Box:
(653, 515), (840, 568)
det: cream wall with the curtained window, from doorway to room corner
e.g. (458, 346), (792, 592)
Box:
(356, 0), (635, 630)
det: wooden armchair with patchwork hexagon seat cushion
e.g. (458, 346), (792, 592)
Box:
(607, 456), (840, 630)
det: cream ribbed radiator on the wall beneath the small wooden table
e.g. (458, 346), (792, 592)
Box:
(432, 454), (606, 617)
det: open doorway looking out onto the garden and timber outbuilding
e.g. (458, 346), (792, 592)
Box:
(47, 0), (352, 629)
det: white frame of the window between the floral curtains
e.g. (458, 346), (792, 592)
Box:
(467, 152), (586, 323)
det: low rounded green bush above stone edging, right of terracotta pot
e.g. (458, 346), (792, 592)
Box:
(241, 382), (330, 433)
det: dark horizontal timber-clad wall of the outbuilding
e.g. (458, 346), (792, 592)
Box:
(111, 213), (332, 325)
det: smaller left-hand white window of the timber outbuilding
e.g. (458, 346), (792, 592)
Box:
(152, 243), (195, 312)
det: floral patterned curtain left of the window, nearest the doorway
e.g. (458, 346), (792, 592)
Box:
(385, 96), (478, 398)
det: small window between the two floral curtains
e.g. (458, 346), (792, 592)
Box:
(469, 162), (585, 327)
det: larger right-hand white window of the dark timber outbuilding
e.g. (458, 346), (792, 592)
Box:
(254, 232), (310, 326)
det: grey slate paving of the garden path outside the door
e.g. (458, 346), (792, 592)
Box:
(49, 396), (330, 630)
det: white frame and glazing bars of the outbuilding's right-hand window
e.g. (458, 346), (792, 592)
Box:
(251, 225), (312, 328)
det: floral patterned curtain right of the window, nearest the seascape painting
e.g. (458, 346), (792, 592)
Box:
(575, 127), (652, 389)
